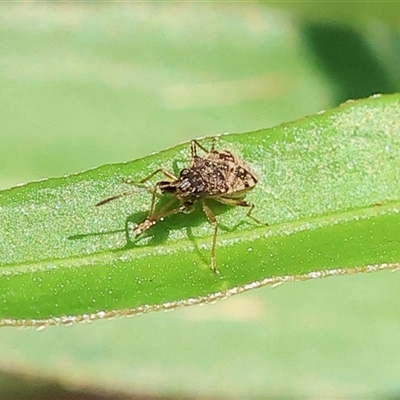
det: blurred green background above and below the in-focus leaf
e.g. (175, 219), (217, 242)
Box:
(0, 2), (400, 399)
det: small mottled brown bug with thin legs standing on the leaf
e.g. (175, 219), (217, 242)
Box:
(96, 139), (262, 273)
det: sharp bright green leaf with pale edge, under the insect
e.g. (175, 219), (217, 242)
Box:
(0, 95), (400, 325)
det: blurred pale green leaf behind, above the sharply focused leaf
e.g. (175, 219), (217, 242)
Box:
(0, 3), (332, 188)
